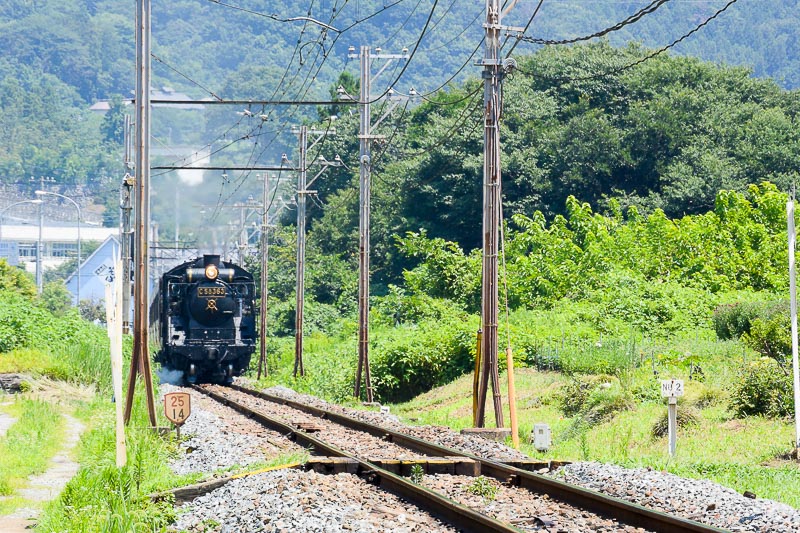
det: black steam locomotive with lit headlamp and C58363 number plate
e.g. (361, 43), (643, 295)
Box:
(150, 255), (256, 383)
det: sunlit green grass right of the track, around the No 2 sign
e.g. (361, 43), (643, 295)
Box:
(392, 369), (800, 508)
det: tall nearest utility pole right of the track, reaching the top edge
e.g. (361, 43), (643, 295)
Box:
(477, 0), (516, 428)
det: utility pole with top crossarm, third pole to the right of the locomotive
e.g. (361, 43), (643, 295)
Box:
(346, 46), (409, 402)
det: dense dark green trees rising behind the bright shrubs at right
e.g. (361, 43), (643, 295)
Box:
(296, 43), (800, 287)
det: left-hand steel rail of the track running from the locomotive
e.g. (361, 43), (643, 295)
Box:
(192, 385), (521, 533)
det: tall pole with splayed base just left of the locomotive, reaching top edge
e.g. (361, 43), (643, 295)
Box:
(125, 0), (156, 427)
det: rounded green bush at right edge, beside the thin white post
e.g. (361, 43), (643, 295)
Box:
(730, 357), (794, 418)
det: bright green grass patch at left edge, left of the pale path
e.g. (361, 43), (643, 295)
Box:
(0, 398), (64, 496)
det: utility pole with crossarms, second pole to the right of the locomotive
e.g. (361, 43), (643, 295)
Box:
(293, 126), (340, 377)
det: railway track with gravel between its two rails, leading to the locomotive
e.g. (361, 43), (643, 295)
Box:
(194, 385), (723, 532)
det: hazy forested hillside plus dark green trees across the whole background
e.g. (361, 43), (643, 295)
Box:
(0, 0), (800, 237)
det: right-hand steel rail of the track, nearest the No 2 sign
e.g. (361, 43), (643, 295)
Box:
(230, 384), (726, 533)
